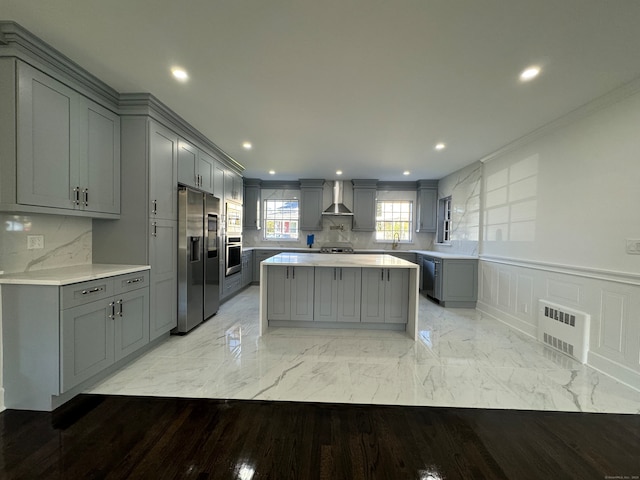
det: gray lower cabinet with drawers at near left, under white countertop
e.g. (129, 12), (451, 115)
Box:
(2, 271), (149, 410)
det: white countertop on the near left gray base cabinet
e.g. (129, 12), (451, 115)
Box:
(0, 264), (151, 285)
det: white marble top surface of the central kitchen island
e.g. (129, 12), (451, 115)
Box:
(260, 252), (418, 269)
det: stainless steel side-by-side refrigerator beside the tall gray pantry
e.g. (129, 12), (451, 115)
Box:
(172, 187), (220, 333)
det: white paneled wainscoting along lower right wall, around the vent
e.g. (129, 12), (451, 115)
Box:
(477, 255), (640, 390)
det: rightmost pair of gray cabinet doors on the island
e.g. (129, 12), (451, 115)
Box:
(361, 268), (409, 323)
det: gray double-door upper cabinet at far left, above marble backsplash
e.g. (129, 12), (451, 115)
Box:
(7, 59), (120, 218)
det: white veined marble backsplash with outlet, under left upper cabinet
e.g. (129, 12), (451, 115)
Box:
(0, 214), (92, 273)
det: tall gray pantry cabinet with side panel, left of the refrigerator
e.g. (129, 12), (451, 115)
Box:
(93, 115), (178, 340)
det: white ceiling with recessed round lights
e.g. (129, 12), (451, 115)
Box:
(0, 0), (640, 180)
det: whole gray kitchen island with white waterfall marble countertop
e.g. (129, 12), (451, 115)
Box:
(260, 252), (420, 340)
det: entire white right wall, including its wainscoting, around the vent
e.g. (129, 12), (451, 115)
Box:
(478, 88), (640, 389)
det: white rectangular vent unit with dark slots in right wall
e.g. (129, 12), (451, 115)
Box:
(538, 300), (590, 363)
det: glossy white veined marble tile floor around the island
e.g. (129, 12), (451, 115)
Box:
(90, 287), (640, 413)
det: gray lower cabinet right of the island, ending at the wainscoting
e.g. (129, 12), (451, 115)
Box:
(421, 255), (478, 308)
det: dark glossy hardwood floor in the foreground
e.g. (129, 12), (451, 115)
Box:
(0, 395), (640, 480)
